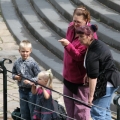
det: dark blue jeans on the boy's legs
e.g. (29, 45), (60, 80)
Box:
(19, 89), (31, 120)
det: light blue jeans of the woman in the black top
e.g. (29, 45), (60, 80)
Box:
(91, 87), (116, 120)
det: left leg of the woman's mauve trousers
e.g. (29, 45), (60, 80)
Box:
(63, 85), (74, 120)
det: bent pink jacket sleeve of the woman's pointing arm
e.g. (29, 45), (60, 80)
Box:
(65, 43), (87, 61)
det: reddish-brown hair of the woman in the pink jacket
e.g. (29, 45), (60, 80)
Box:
(73, 5), (91, 22)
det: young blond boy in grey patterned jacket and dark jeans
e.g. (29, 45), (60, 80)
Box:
(12, 40), (40, 120)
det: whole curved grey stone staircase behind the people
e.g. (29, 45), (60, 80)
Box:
(1, 0), (120, 117)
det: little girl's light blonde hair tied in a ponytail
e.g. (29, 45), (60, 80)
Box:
(38, 69), (53, 89)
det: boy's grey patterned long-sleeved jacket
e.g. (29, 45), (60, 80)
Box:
(12, 57), (40, 88)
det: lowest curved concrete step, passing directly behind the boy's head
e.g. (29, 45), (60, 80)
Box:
(1, 0), (63, 81)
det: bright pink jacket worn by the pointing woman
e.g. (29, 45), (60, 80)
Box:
(63, 22), (97, 84)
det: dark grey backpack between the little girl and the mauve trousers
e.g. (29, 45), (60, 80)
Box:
(53, 100), (67, 120)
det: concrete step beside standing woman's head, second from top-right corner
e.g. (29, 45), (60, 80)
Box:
(72, 0), (120, 31)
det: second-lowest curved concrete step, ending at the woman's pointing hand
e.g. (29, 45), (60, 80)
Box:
(13, 0), (64, 59)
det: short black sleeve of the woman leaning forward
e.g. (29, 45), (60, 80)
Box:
(86, 54), (99, 79)
